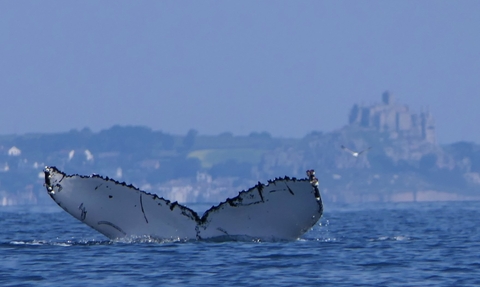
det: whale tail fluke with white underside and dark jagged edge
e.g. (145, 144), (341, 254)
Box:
(44, 167), (323, 240)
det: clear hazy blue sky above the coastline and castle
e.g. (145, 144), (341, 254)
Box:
(0, 0), (480, 143)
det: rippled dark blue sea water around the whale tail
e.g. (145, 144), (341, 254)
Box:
(0, 202), (480, 286)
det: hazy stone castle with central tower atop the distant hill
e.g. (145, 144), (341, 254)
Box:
(349, 91), (436, 143)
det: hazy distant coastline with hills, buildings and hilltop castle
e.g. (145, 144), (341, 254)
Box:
(0, 92), (480, 205)
